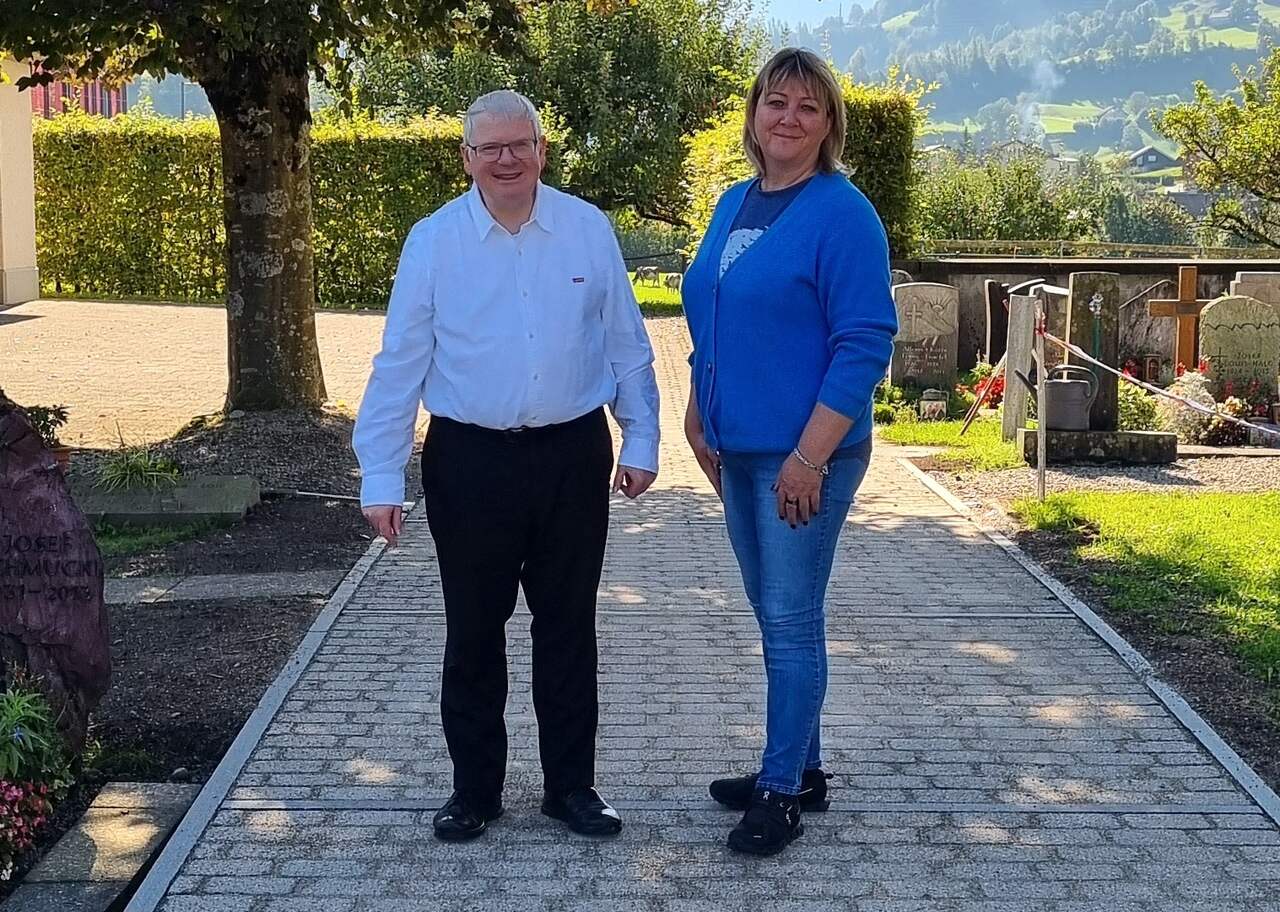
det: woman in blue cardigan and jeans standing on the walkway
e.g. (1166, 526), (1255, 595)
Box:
(684, 49), (897, 854)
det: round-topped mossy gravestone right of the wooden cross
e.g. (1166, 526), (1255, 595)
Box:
(1199, 295), (1280, 400)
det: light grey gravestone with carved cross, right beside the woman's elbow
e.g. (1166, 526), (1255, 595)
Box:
(888, 282), (960, 387)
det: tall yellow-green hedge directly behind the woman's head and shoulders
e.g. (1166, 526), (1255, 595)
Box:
(686, 74), (925, 255)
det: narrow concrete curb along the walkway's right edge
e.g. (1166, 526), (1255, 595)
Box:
(897, 456), (1280, 825)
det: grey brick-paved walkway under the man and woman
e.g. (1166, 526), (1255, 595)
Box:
(104, 318), (1280, 912)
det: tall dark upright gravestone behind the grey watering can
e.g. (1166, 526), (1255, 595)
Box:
(1066, 273), (1120, 430)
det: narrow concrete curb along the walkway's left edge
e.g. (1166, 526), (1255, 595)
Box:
(124, 538), (387, 912)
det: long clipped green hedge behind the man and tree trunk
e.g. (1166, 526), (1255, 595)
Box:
(35, 114), (466, 307)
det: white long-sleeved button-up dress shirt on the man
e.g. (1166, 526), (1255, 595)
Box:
(352, 183), (658, 506)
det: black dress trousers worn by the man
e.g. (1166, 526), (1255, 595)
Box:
(422, 409), (613, 795)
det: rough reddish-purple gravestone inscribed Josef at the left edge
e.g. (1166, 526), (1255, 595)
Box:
(0, 392), (111, 752)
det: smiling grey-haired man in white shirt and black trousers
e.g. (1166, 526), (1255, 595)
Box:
(353, 91), (658, 839)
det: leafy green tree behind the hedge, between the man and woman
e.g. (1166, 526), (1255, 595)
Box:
(356, 0), (762, 222)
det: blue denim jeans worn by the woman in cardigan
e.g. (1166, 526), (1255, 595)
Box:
(721, 438), (870, 795)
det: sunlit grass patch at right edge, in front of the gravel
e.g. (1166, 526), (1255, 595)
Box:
(1014, 493), (1280, 696)
